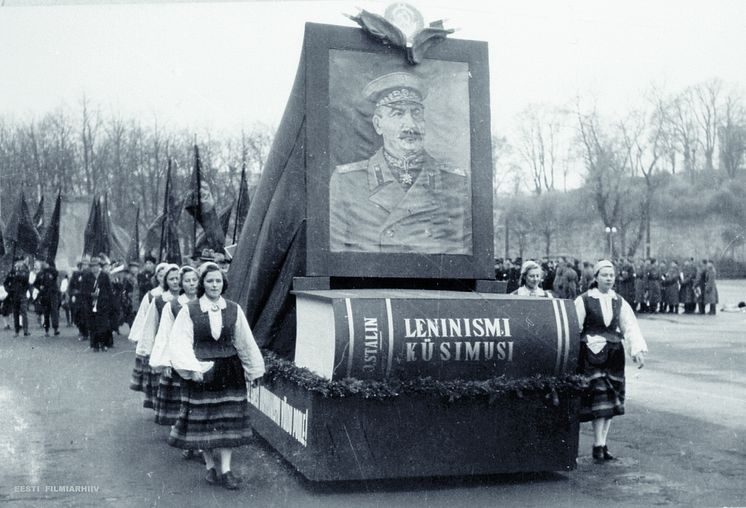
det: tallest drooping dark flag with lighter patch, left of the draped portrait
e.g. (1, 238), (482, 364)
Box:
(185, 145), (225, 254)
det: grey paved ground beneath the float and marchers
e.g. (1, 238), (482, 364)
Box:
(0, 281), (746, 507)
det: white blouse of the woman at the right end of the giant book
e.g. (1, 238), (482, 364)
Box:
(575, 288), (648, 356)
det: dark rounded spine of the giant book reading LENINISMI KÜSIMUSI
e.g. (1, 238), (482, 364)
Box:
(332, 298), (580, 379)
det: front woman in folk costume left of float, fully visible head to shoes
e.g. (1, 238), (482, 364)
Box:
(168, 263), (264, 490)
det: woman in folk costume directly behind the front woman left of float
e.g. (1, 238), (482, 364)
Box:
(150, 266), (199, 425)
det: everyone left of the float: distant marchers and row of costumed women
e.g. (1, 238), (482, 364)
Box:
(0, 250), (265, 490)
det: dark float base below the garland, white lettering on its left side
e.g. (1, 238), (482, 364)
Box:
(249, 380), (579, 481)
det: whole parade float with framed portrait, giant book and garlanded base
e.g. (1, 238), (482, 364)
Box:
(228, 4), (582, 481)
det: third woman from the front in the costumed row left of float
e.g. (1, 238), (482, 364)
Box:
(135, 264), (181, 409)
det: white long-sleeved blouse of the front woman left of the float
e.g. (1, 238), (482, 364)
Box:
(169, 296), (264, 381)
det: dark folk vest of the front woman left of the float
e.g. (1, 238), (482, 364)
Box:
(187, 299), (238, 362)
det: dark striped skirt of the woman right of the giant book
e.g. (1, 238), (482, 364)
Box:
(579, 342), (624, 422)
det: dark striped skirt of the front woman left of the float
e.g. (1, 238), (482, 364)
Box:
(168, 356), (252, 450)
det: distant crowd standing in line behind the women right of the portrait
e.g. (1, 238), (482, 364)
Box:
(495, 257), (719, 314)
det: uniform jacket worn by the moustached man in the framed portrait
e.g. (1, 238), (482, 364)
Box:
(329, 148), (472, 254)
